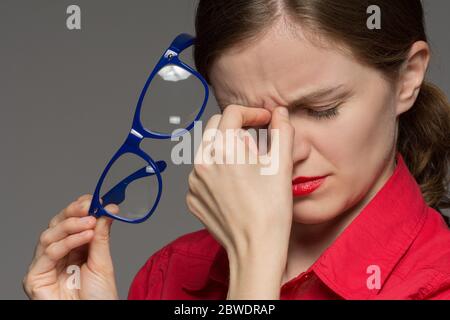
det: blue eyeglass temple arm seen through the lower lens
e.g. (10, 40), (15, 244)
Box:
(102, 161), (167, 206)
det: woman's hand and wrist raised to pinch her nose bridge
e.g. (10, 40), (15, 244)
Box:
(186, 105), (294, 299)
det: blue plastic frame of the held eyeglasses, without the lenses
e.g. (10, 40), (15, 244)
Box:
(88, 33), (209, 224)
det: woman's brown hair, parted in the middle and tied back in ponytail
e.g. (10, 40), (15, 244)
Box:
(194, 0), (450, 219)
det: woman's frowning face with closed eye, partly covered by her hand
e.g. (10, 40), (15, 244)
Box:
(210, 23), (397, 224)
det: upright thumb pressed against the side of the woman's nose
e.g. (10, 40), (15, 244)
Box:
(269, 107), (295, 166)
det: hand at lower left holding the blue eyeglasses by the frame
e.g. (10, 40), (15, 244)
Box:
(23, 195), (119, 299)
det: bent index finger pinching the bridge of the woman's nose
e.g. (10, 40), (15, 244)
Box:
(218, 105), (271, 134)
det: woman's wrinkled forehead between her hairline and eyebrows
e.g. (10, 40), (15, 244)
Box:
(210, 23), (360, 105)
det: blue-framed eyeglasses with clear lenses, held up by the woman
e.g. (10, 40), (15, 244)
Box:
(89, 33), (209, 223)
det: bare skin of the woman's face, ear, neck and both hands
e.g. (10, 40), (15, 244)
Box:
(23, 16), (429, 299)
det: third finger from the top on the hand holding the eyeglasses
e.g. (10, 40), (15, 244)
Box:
(29, 230), (94, 274)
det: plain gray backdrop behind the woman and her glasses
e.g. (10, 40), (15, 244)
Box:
(0, 0), (450, 299)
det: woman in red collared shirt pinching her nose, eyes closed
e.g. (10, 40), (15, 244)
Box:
(24, 0), (450, 299)
